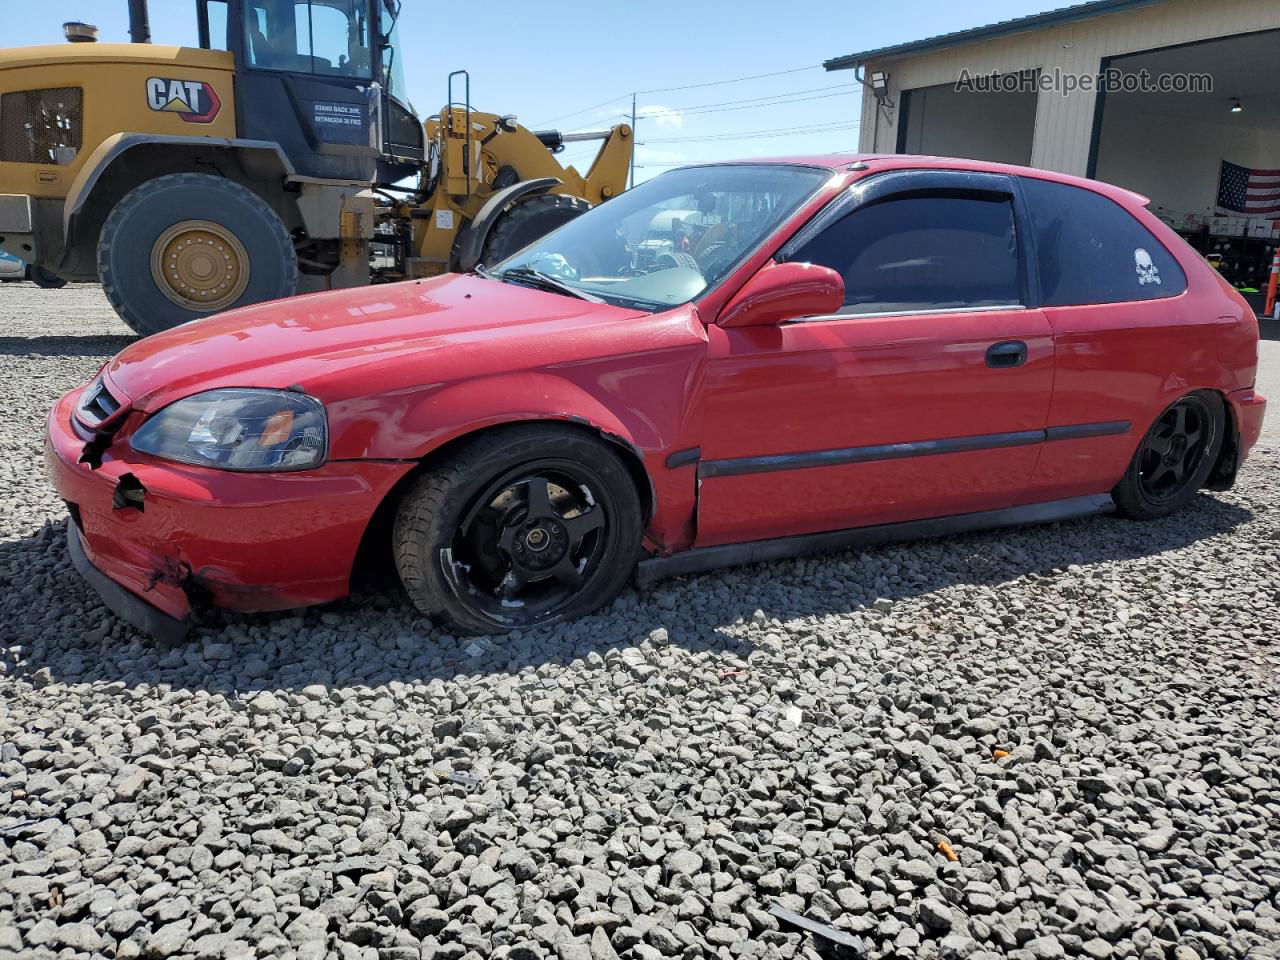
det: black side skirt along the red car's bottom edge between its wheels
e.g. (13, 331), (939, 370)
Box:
(635, 494), (1115, 588)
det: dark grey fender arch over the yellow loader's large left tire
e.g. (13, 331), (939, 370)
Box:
(63, 143), (301, 275)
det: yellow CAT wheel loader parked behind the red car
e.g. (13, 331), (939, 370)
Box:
(0, 0), (632, 334)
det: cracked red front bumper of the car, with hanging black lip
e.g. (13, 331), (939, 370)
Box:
(45, 390), (412, 637)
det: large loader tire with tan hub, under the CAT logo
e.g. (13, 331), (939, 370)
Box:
(97, 173), (298, 335)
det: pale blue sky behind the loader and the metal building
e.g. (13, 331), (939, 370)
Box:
(0, 0), (1049, 180)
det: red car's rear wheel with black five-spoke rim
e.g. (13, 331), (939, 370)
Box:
(1111, 390), (1226, 520)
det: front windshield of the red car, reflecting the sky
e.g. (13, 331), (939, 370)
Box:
(493, 164), (831, 308)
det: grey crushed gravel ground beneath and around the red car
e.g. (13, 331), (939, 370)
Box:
(0, 285), (1280, 960)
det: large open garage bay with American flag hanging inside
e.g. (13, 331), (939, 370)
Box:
(1089, 31), (1280, 310)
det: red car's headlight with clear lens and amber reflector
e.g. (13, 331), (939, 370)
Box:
(131, 387), (329, 470)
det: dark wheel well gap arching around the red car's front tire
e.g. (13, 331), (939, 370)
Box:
(351, 419), (654, 589)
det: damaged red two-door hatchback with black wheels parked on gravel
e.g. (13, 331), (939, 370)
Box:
(47, 156), (1265, 636)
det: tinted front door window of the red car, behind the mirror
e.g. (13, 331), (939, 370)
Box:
(788, 196), (1021, 314)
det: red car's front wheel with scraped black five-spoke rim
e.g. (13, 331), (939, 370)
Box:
(393, 425), (643, 634)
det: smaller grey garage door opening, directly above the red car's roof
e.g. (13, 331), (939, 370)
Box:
(897, 72), (1037, 164)
